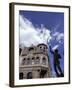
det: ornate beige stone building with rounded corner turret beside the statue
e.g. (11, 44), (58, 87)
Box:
(19, 44), (51, 79)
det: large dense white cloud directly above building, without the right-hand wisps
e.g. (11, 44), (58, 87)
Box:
(20, 15), (51, 47)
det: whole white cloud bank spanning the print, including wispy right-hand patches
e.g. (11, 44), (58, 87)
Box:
(19, 15), (64, 50)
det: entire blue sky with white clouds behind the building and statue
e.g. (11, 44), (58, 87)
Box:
(19, 11), (64, 75)
